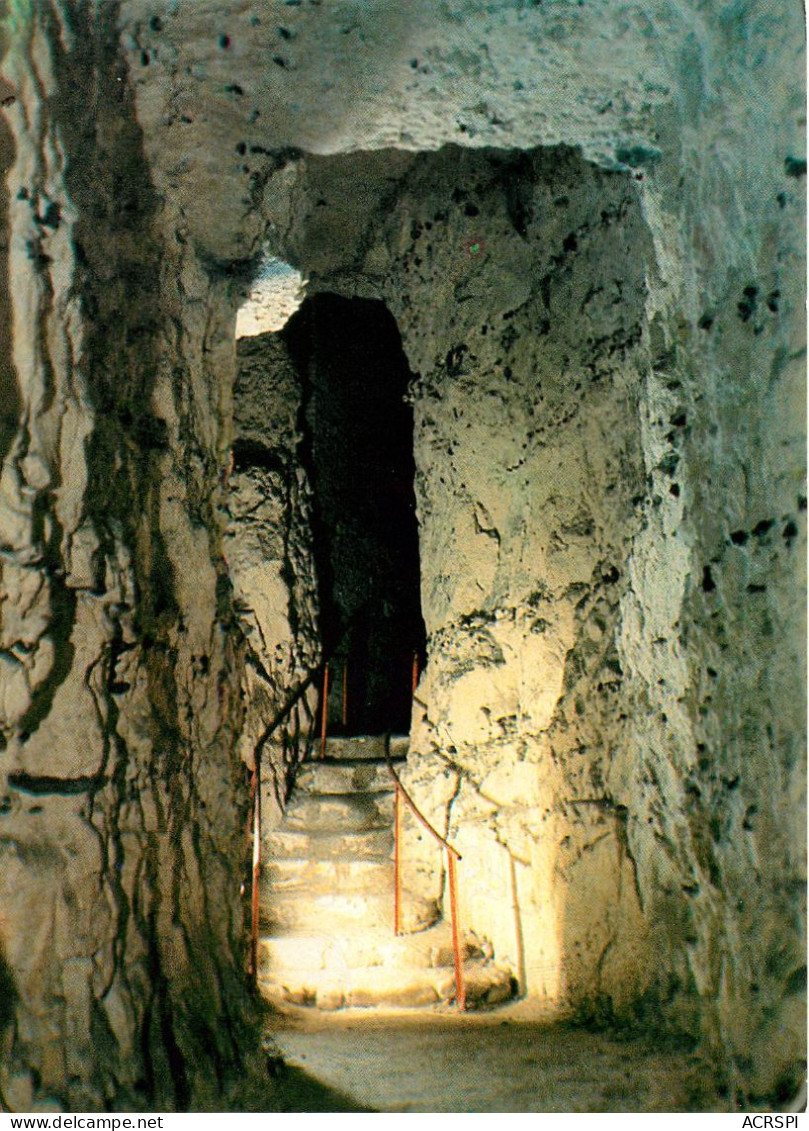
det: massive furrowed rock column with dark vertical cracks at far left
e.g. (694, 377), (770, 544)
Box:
(0, 2), (256, 1111)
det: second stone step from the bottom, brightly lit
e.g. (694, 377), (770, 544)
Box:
(258, 923), (491, 981)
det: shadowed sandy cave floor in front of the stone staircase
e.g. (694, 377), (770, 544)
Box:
(265, 1004), (733, 1113)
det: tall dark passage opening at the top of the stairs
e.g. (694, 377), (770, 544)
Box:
(284, 294), (425, 734)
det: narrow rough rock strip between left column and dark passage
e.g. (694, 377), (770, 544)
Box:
(224, 334), (320, 818)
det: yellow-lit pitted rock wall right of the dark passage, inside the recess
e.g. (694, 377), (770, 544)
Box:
(402, 154), (649, 1022)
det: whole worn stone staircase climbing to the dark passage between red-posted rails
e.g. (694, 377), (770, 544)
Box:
(258, 737), (513, 1010)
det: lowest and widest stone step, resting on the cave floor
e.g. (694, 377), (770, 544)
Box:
(258, 961), (514, 1010)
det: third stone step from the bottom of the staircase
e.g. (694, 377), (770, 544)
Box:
(261, 886), (438, 938)
